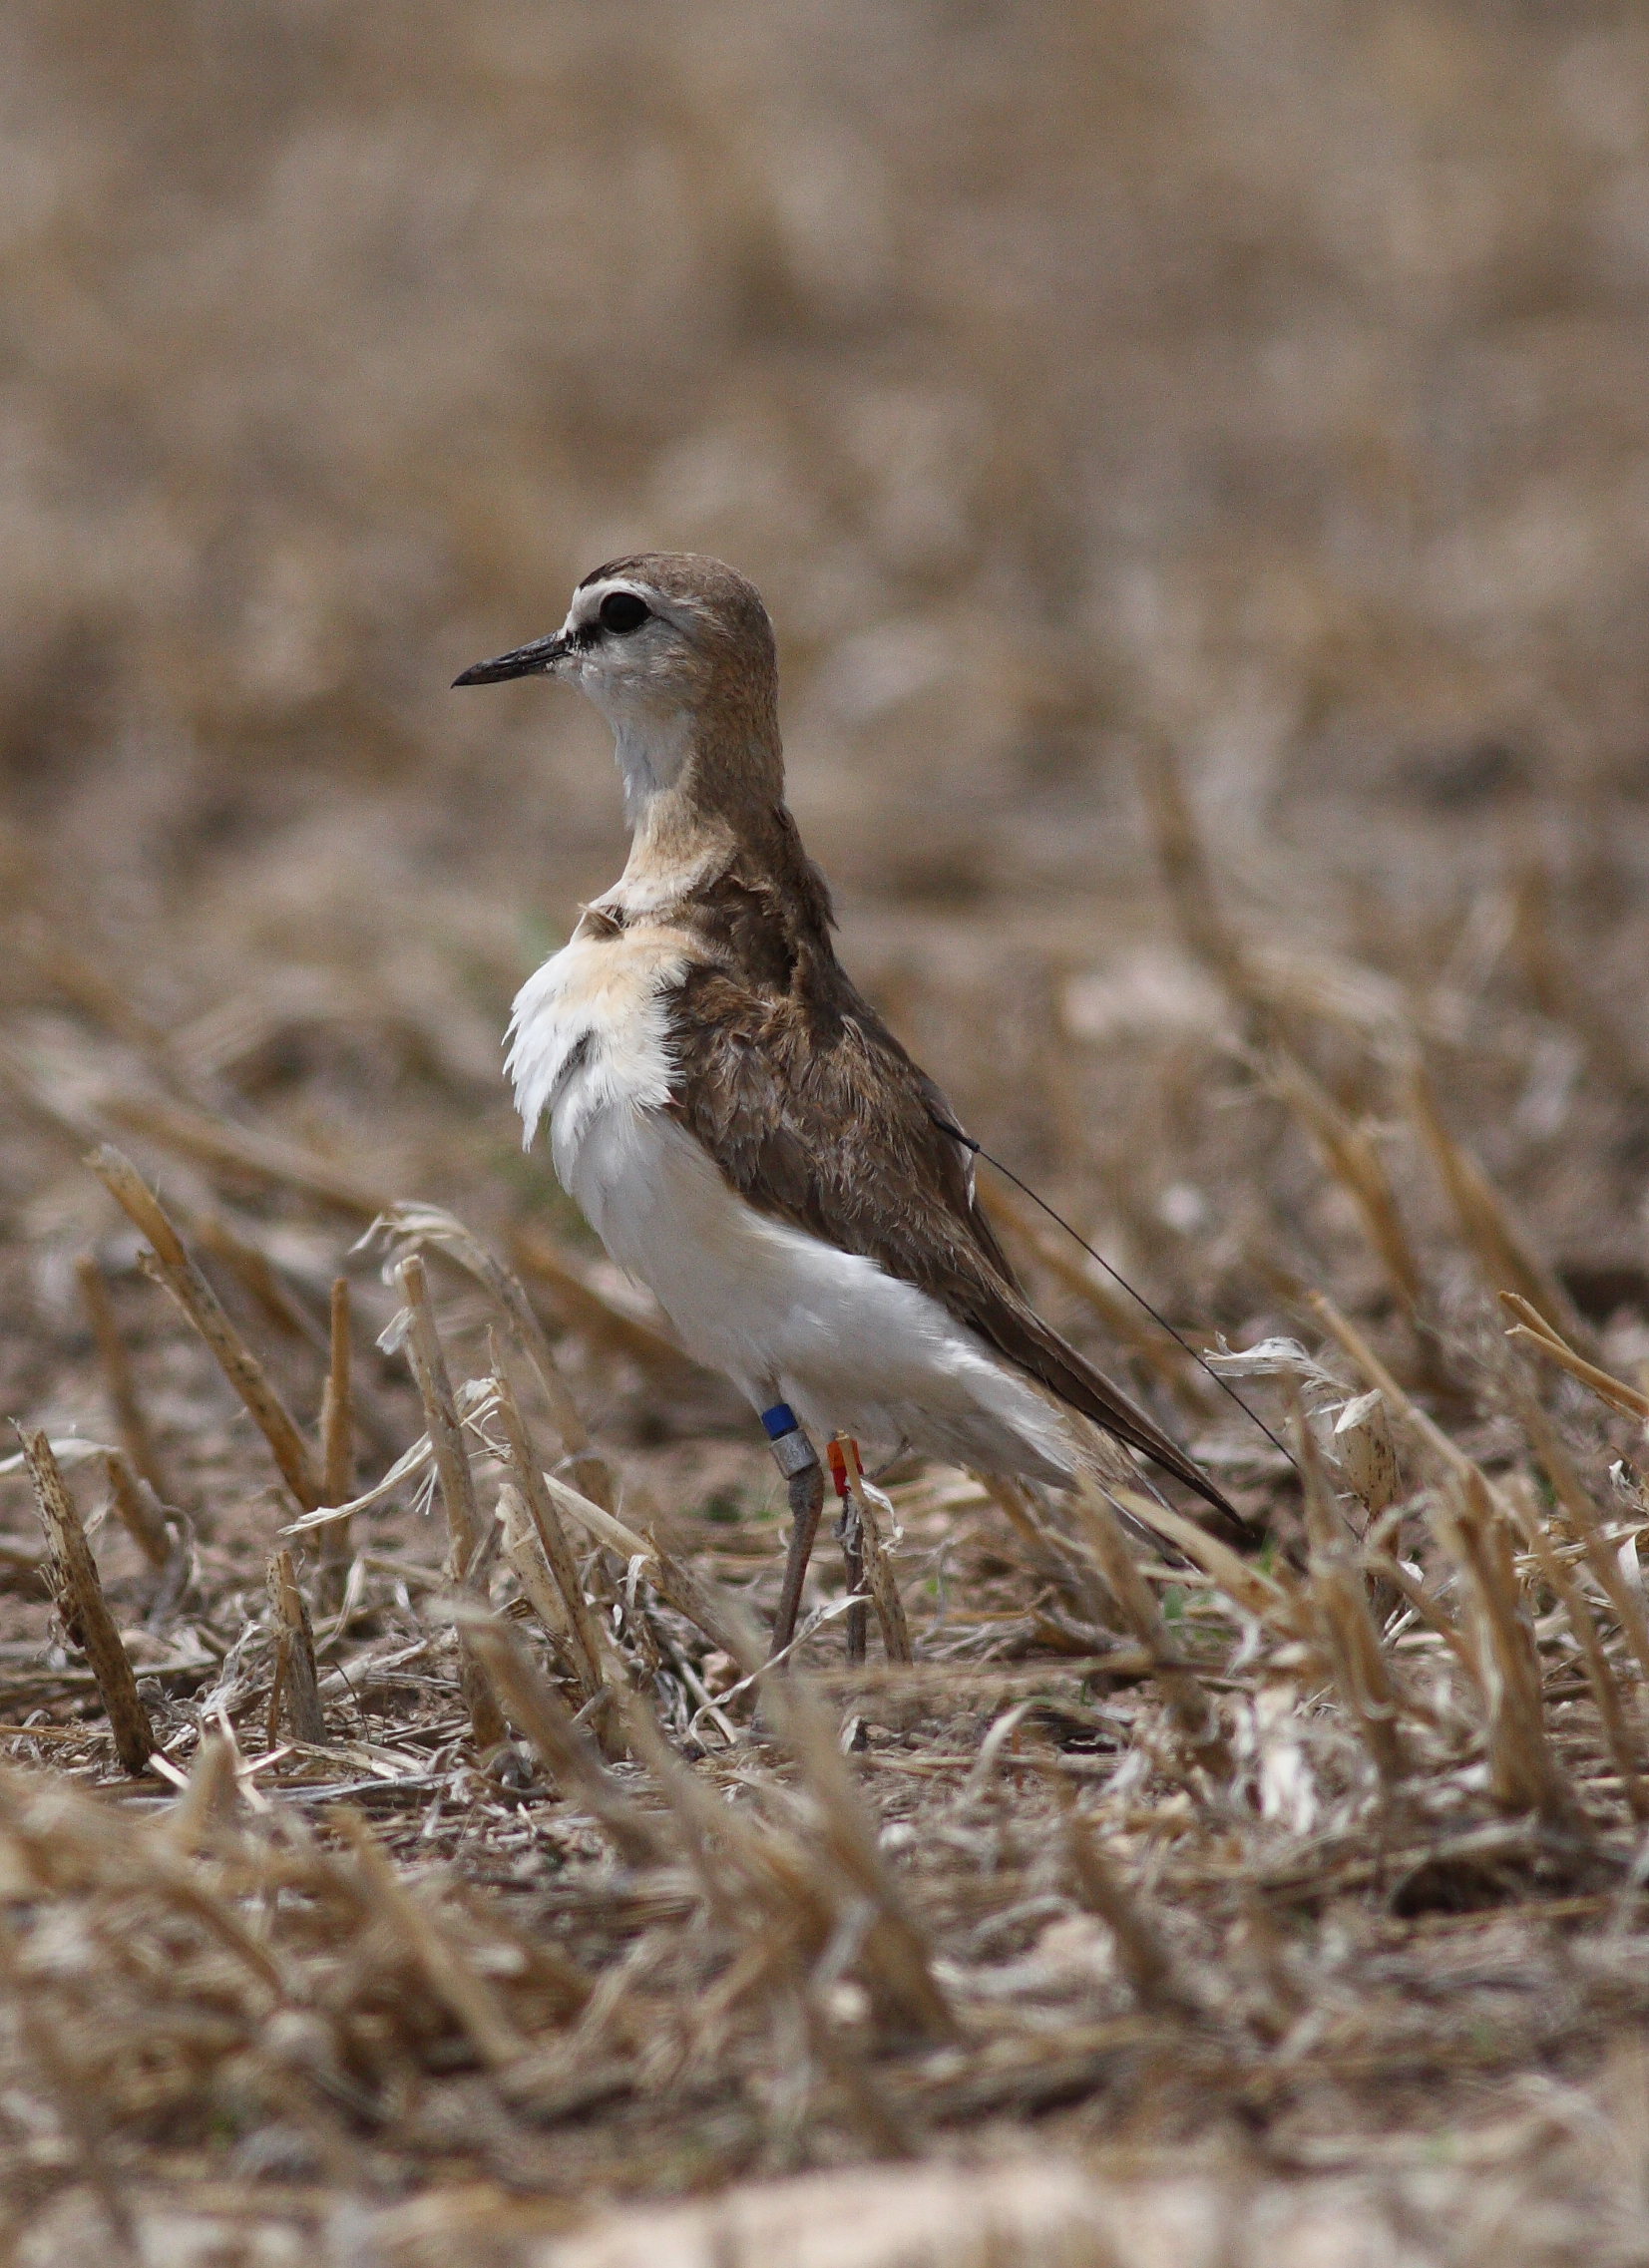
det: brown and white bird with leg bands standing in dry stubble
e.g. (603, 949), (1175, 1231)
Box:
(454, 552), (1248, 1651)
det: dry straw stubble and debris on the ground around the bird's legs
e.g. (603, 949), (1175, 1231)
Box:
(0, 784), (1649, 2268)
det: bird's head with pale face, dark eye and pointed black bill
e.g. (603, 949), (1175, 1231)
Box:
(454, 552), (778, 814)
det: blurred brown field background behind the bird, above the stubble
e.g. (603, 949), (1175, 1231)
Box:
(0, 0), (1649, 1324)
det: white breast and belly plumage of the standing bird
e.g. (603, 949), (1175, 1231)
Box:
(511, 933), (1079, 1481)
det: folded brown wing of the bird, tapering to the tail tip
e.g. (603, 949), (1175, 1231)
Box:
(666, 948), (1248, 1540)
